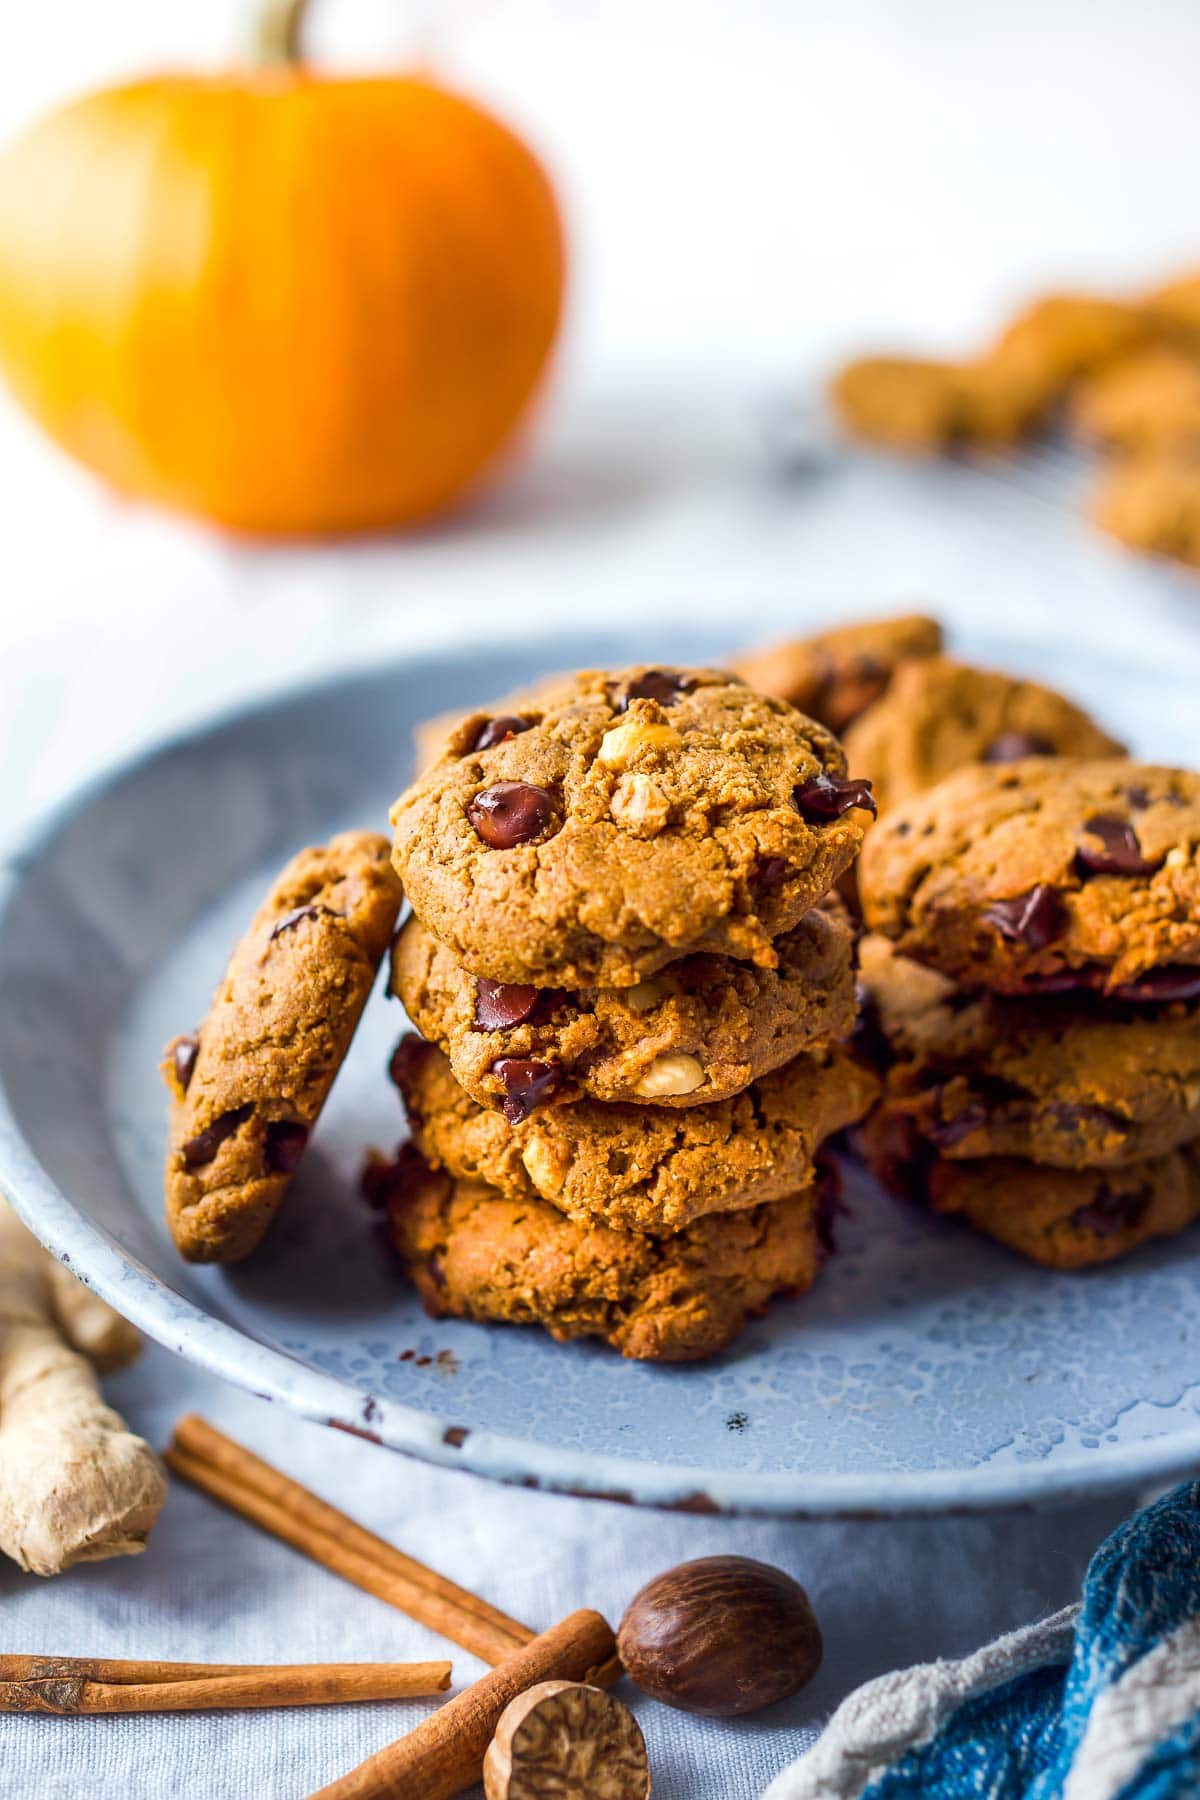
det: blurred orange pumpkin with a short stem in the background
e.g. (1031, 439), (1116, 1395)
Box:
(0, 0), (563, 535)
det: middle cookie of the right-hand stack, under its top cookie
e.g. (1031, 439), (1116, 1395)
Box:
(860, 938), (1200, 1168)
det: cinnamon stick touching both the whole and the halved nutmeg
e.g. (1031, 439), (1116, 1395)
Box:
(311, 1611), (615, 1800)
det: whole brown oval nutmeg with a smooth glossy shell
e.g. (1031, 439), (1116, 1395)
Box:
(617, 1557), (822, 1719)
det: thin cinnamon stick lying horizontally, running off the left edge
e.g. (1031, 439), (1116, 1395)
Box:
(0, 1656), (450, 1714)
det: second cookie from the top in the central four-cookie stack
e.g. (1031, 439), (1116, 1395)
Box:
(392, 896), (855, 1121)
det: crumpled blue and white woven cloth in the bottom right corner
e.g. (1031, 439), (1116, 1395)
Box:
(765, 1481), (1200, 1800)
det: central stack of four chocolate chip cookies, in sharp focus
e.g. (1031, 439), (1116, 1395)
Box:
(379, 668), (878, 1361)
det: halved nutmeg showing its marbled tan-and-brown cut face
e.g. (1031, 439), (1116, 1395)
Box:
(484, 1681), (649, 1800)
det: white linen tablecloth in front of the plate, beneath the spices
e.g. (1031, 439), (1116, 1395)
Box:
(0, 1348), (1132, 1800)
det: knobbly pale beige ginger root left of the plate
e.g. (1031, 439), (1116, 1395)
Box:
(0, 1197), (167, 1575)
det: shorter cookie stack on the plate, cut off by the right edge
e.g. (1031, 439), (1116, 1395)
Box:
(858, 758), (1200, 1269)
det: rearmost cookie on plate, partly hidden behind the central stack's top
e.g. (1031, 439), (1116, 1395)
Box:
(730, 612), (941, 733)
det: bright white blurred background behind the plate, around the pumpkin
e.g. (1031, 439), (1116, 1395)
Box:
(0, 0), (1200, 828)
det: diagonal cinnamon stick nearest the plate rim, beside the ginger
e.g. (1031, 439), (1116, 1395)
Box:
(164, 1415), (534, 1663)
